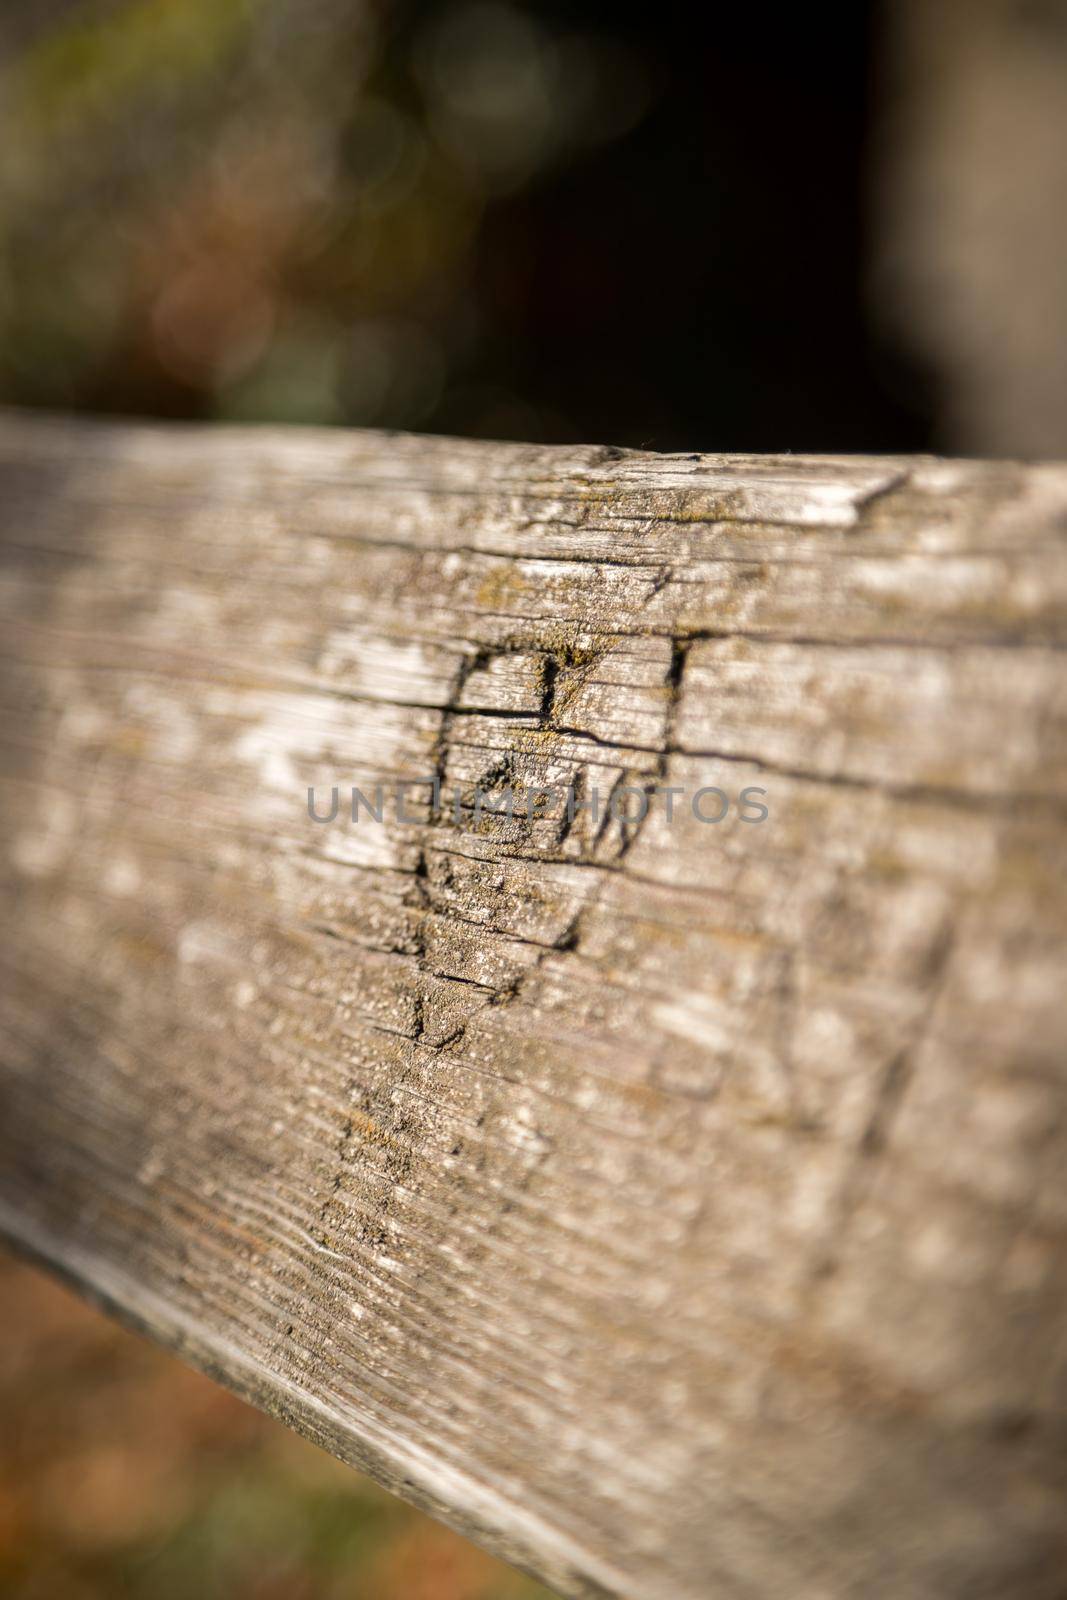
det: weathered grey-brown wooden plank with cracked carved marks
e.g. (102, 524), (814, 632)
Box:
(0, 416), (1067, 1600)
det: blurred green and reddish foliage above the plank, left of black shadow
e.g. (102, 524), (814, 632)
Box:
(0, 0), (651, 437)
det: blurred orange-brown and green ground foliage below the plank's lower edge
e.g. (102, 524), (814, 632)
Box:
(0, 1256), (547, 1600)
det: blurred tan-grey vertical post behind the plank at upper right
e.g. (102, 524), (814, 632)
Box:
(869, 0), (1067, 458)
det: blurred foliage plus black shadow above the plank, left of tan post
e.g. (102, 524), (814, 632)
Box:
(0, 0), (931, 450)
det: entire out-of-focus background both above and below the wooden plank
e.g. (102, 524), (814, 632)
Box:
(0, 0), (1067, 1600)
